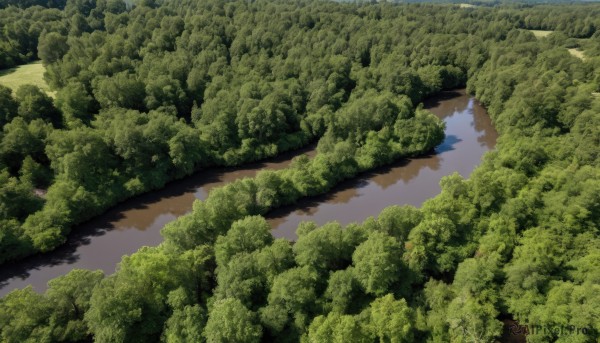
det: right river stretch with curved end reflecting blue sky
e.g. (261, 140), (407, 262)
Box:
(268, 90), (498, 239)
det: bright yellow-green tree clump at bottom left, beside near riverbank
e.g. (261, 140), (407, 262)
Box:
(85, 247), (213, 342)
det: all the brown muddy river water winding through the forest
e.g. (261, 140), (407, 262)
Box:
(0, 90), (497, 296)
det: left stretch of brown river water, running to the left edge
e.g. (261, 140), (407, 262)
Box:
(0, 146), (316, 296)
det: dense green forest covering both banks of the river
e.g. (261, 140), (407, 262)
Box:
(0, 0), (600, 343)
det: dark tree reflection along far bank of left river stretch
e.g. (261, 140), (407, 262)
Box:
(0, 145), (314, 290)
